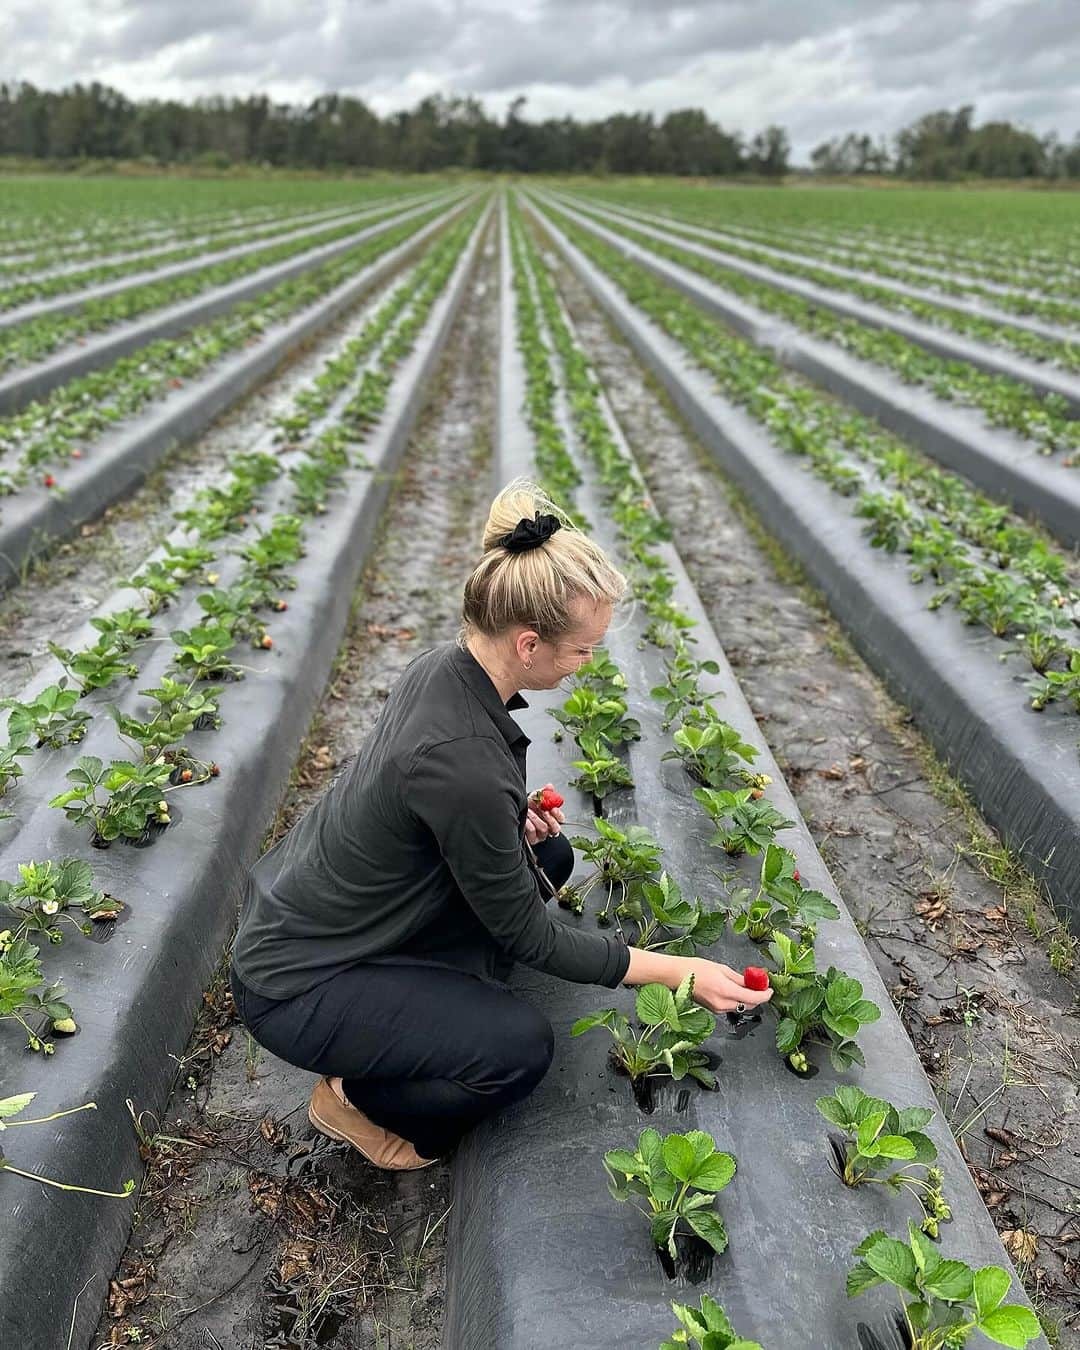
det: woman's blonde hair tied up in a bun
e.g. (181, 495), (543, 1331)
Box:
(460, 478), (626, 643)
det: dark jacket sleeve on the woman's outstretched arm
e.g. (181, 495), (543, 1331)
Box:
(406, 736), (630, 988)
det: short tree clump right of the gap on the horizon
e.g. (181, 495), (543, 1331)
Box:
(810, 104), (1080, 180)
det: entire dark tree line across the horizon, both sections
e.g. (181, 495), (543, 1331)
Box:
(0, 82), (1080, 180)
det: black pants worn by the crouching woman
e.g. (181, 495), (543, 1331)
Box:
(232, 836), (574, 1158)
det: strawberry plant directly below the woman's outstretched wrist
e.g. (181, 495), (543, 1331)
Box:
(570, 975), (717, 1100)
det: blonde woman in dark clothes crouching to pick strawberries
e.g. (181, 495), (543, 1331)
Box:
(232, 482), (770, 1169)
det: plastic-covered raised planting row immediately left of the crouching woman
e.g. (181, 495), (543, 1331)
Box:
(0, 199), (490, 1345)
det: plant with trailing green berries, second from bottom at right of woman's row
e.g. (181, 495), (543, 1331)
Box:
(817, 1084), (952, 1238)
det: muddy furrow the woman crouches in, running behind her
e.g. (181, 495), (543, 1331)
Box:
(93, 234), (498, 1350)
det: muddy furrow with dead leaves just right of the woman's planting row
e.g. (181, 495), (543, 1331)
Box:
(549, 255), (1080, 1347)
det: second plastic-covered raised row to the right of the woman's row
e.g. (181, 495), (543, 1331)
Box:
(531, 191), (1080, 545)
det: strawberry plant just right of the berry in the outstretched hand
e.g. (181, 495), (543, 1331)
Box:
(770, 929), (882, 1073)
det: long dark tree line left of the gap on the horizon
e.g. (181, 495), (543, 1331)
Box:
(0, 84), (790, 177)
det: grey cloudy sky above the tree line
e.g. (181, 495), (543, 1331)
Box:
(0, 0), (1080, 161)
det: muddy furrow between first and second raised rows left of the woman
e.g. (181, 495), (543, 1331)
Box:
(0, 267), (407, 697)
